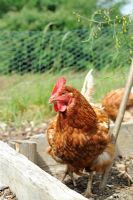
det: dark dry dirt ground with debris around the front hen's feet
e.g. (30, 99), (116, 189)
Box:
(65, 158), (133, 200)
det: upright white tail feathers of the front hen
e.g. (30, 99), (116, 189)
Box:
(81, 69), (94, 101)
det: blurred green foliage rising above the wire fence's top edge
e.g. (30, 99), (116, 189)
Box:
(0, 0), (96, 30)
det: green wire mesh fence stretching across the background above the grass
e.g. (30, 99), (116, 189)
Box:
(0, 25), (133, 74)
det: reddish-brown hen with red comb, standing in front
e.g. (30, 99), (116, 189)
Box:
(47, 78), (114, 197)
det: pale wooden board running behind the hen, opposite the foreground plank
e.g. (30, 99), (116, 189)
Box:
(31, 122), (133, 178)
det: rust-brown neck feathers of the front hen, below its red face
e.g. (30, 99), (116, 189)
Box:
(57, 90), (97, 132)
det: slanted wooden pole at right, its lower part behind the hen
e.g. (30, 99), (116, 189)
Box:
(100, 60), (133, 189)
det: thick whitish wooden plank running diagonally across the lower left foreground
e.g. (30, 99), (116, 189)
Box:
(0, 141), (87, 200)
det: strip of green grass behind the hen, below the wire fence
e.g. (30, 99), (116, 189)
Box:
(0, 68), (128, 125)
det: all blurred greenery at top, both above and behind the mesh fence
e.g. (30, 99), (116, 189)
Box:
(0, 0), (133, 74)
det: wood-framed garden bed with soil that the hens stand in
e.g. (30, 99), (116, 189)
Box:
(0, 122), (133, 200)
